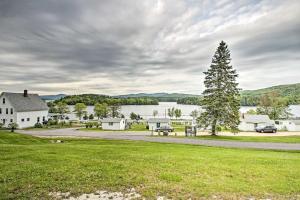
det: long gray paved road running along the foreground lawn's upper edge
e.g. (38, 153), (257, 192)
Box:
(18, 128), (300, 150)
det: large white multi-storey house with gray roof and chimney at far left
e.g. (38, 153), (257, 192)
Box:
(0, 90), (48, 128)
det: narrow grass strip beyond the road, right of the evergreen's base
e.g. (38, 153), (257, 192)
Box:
(190, 135), (300, 143)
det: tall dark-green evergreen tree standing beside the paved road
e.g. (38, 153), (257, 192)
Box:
(199, 41), (240, 135)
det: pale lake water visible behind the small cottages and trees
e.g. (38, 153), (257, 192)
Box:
(69, 102), (300, 119)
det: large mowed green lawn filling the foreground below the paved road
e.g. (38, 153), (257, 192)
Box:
(0, 132), (300, 199)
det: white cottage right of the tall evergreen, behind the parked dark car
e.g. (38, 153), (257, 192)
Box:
(238, 114), (274, 131)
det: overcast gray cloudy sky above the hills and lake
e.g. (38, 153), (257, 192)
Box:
(0, 0), (300, 95)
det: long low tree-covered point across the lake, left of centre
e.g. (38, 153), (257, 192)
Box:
(55, 94), (158, 106)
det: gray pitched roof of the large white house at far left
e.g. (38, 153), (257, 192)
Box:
(0, 92), (49, 112)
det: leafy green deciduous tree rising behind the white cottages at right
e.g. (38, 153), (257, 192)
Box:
(257, 92), (291, 119)
